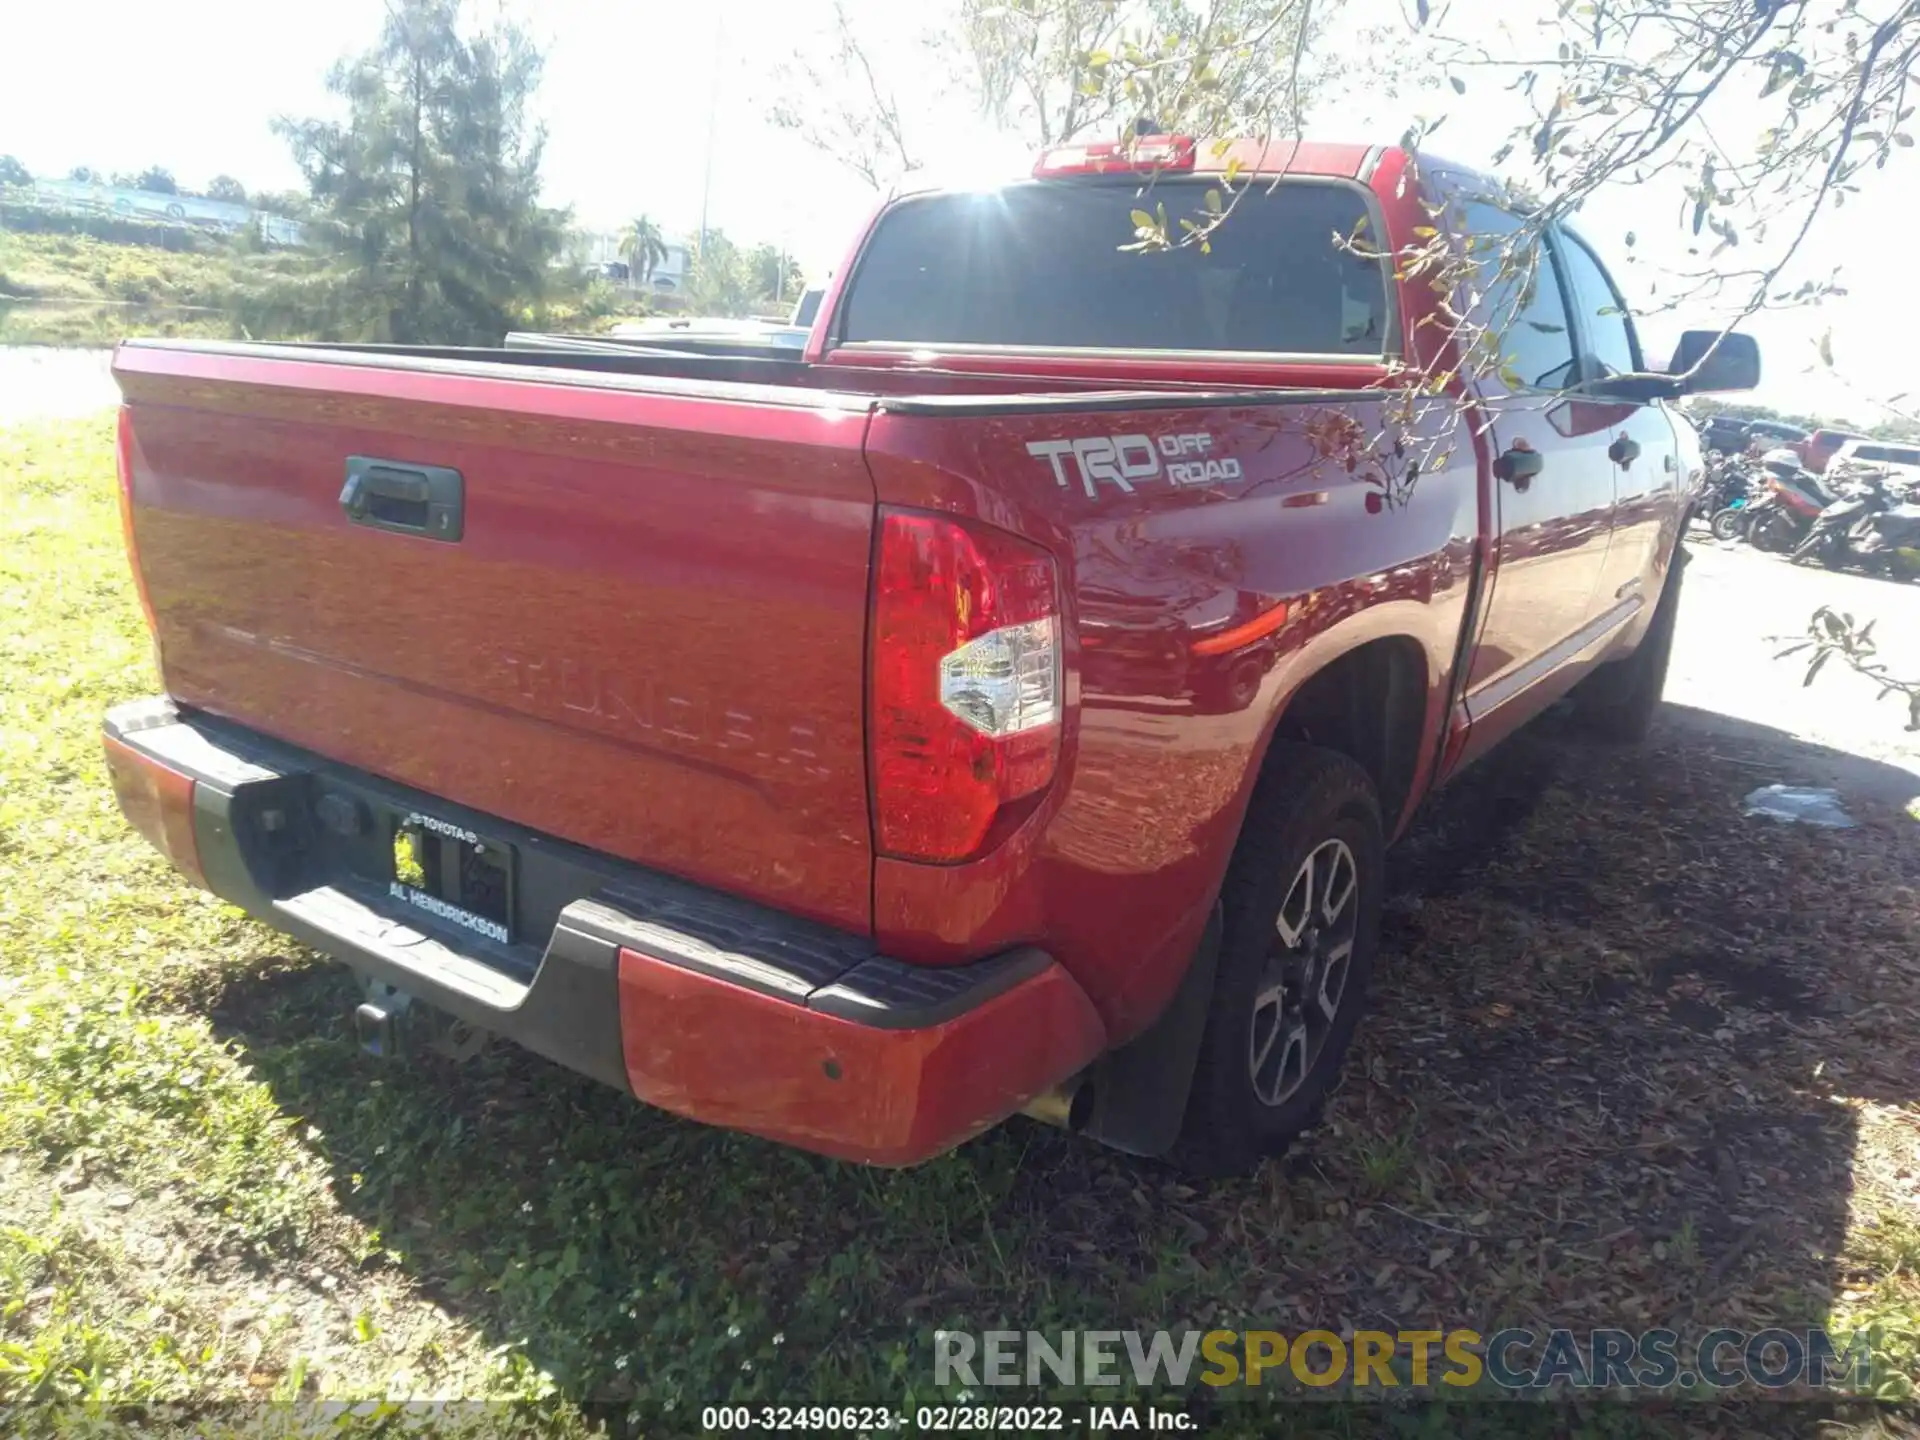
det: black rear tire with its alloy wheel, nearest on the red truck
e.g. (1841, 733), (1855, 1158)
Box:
(1167, 741), (1386, 1177)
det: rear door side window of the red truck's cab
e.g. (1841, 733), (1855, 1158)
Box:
(1457, 200), (1576, 392)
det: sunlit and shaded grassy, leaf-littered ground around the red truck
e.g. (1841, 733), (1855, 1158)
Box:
(0, 410), (1920, 1436)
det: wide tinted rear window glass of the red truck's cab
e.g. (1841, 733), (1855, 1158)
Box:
(841, 180), (1388, 355)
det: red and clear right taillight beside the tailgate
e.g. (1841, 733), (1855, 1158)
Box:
(868, 511), (1062, 862)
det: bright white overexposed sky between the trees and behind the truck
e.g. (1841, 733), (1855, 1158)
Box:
(0, 0), (1920, 420)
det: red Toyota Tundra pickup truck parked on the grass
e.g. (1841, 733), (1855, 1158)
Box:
(106, 140), (1759, 1171)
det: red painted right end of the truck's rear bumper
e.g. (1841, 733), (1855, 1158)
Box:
(620, 948), (1106, 1165)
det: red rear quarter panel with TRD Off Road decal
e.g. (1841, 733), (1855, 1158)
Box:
(868, 394), (1480, 1039)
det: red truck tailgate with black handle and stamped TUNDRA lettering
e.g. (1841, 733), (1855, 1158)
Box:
(115, 344), (874, 931)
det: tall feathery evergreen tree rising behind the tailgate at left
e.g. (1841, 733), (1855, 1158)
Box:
(278, 0), (566, 344)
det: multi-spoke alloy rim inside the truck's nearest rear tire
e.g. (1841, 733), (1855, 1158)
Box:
(1246, 839), (1359, 1108)
